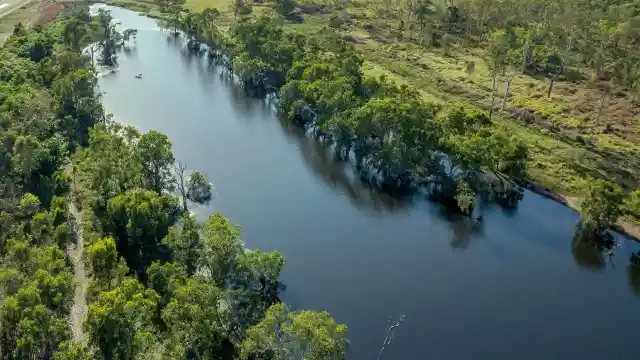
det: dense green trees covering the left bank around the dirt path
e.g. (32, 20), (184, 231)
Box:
(0, 8), (347, 360)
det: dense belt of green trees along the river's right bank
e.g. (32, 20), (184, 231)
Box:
(176, 9), (528, 217)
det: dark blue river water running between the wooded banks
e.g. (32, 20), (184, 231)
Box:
(91, 8), (640, 360)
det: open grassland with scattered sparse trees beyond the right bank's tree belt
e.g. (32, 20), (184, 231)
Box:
(109, 0), (640, 234)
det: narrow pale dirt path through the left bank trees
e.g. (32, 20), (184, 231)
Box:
(67, 200), (89, 343)
